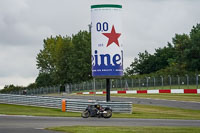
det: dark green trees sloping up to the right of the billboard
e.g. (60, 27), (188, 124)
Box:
(126, 24), (200, 76)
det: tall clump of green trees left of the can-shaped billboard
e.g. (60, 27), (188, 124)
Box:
(36, 31), (91, 86)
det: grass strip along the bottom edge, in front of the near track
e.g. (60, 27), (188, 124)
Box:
(48, 126), (200, 133)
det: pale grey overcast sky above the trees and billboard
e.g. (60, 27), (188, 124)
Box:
(0, 0), (200, 89)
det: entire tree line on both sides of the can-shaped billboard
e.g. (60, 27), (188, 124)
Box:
(1, 24), (200, 92)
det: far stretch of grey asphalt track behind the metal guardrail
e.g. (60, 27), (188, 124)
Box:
(63, 95), (200, 110)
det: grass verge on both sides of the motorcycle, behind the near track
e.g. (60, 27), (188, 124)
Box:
(0, 104), (200, 120)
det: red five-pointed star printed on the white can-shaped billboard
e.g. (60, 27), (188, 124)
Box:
(102, 25), (121, 47)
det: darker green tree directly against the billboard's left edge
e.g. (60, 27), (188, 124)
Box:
(72, 31), (92, 82)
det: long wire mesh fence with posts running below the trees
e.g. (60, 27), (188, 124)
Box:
(1, 75), (200, 95)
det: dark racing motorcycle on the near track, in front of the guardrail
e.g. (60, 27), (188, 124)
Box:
(81, 104), (112, 118)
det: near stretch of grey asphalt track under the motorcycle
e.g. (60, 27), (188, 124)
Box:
(0, 115), (200, 133)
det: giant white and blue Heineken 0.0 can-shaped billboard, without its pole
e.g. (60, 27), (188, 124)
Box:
(91, 4), (123, 78)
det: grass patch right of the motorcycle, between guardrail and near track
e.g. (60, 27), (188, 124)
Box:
(113, 104), (200, 120)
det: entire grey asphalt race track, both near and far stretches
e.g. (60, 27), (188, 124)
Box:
(0, 95), (200, 133)
